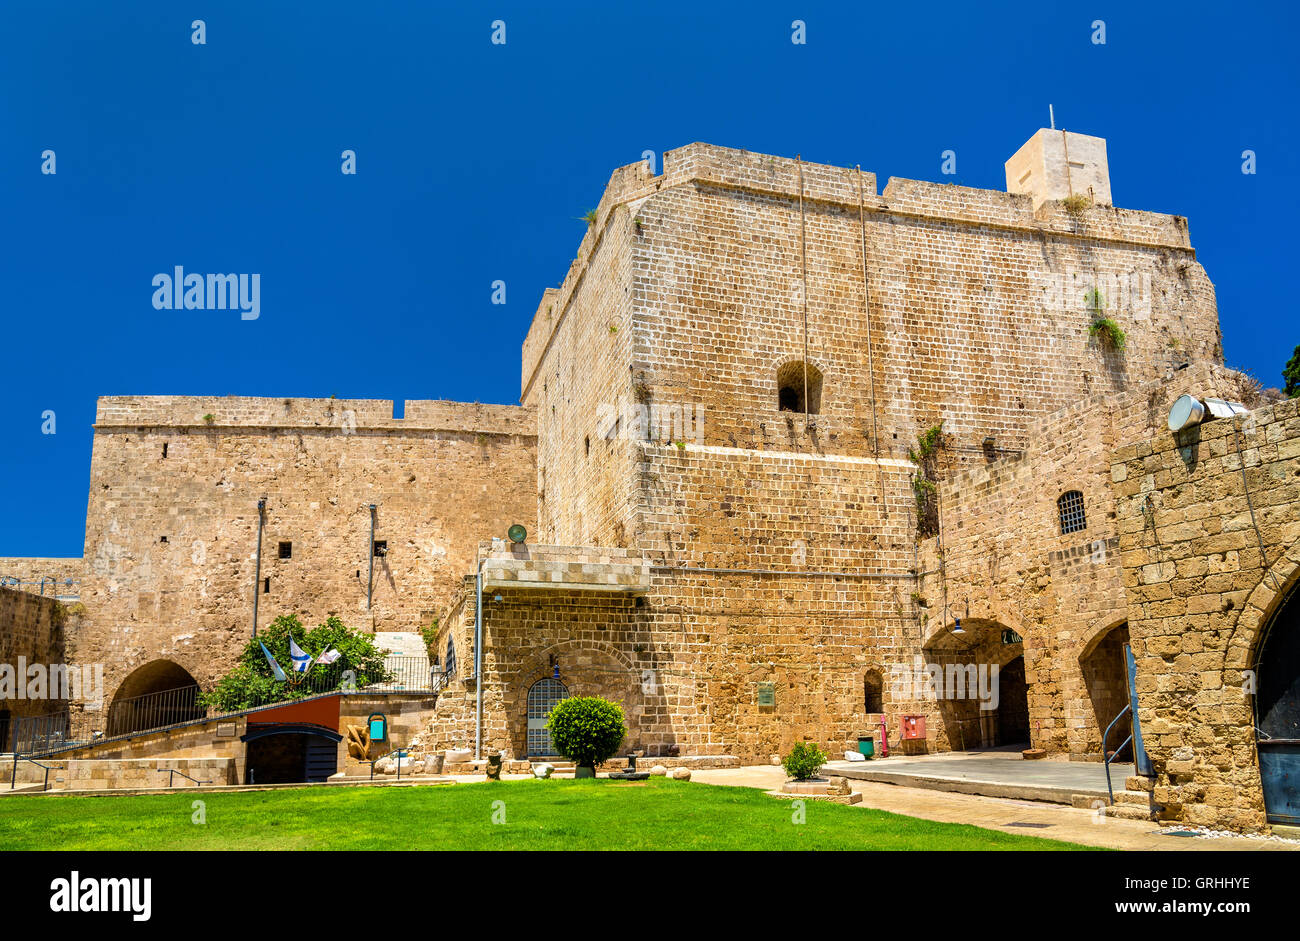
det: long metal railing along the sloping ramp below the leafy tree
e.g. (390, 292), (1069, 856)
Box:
(12, 656), (447, 759)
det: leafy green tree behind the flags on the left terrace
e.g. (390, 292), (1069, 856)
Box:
(200, 615), (391, 712)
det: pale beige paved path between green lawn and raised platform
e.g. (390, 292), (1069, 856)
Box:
(690, 759), (1300, 850)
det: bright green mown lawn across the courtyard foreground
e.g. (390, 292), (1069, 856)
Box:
(0, 779), (1087, 850)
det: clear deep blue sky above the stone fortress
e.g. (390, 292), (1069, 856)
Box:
(0, 0), (1300, 556)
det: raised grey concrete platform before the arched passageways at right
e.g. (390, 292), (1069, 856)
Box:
(823, 750), (1134, 803)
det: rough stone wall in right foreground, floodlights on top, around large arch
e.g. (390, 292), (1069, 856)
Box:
(1112, 382), (1300, 829)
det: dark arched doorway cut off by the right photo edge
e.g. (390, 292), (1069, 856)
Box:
(1255, 590), (1300, 825)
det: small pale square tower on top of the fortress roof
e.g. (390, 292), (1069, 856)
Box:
(1006, 127), (1110, 211)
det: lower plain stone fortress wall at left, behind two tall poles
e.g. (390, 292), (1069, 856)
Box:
(69, 396), (537, 695)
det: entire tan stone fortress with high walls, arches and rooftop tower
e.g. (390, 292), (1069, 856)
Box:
(0, 130), (1300, 831)
